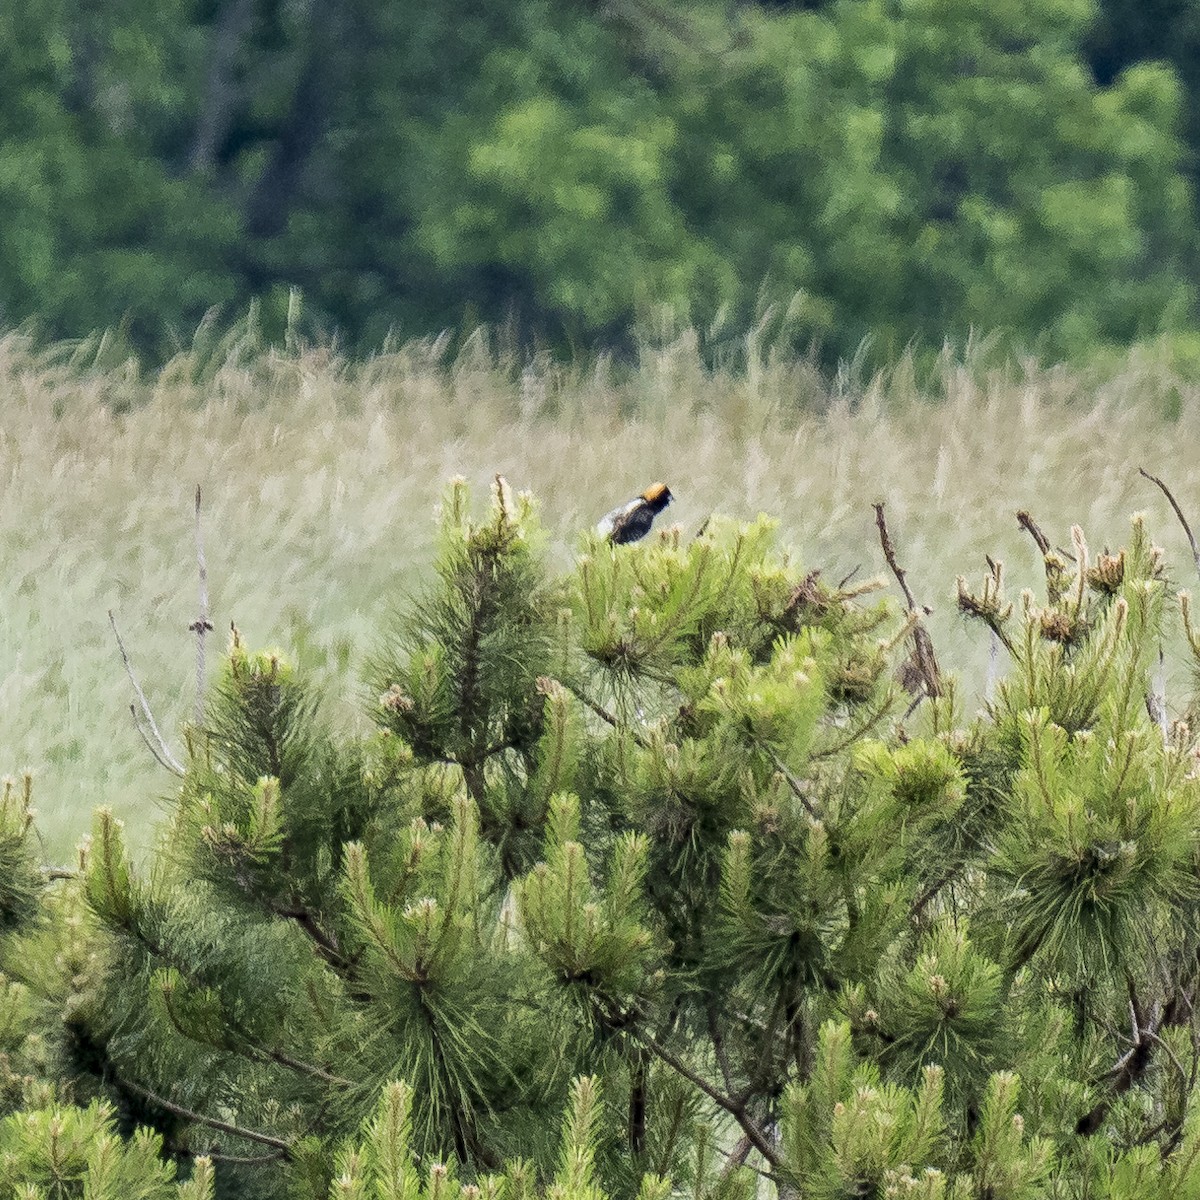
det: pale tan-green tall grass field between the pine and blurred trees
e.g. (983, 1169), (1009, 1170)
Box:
(0, 324), (1200, 858)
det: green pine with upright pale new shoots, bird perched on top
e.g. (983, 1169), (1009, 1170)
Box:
(11, 480), (1200, 1200)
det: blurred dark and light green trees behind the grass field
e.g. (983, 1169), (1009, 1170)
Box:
(0, 0), (1200, 354)
